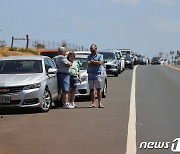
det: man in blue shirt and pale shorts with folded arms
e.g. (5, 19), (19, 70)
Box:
(87, 44), (104, 108)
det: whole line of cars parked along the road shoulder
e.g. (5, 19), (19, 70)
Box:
(0, 49), (139, 112)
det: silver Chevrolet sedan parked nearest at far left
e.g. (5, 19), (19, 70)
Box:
(0, 56), (59, 112)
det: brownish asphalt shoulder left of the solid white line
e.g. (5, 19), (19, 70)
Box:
(0, 70), (132, 154)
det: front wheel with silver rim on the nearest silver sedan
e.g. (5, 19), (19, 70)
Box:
(40, 88), (52, 112)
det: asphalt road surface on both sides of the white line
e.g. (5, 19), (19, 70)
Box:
(0, 66), (180, 154)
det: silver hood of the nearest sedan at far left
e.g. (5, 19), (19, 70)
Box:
(0, 73), (44, 87)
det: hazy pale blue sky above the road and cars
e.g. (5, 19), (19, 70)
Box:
(0, 0), (180, 57)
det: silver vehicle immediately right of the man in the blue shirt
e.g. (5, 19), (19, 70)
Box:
(99, 50), (121, 76)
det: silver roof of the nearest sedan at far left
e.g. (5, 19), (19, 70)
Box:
(0, 55), (49, 60)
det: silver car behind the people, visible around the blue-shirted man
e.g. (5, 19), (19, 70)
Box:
(76, 55), (107, 98)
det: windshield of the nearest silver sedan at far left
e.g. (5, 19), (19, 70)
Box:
(0, 60), (43, 74)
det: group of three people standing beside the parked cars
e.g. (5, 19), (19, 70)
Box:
(56, 44), (104, 109)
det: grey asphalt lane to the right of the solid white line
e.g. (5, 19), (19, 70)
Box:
(136, 66), (180, 154)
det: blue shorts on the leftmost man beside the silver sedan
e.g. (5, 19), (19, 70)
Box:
(58, 73), (70, 91)
